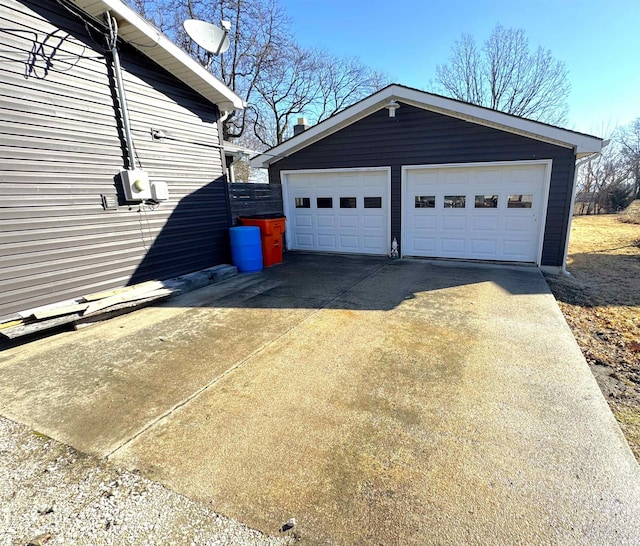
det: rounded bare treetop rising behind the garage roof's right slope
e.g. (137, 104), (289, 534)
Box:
(436, 25), (571, 124)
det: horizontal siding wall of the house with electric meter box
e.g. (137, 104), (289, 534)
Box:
(0, 0), (230, 316)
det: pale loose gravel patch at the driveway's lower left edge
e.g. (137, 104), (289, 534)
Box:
(0, 417), (294, 546)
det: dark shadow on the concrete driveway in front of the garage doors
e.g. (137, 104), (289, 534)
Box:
(165, 252), (548, 311)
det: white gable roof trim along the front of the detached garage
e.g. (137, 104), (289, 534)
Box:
(251, 84), (602, 167)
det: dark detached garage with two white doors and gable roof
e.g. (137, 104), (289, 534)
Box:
(252, 85), (602, 268)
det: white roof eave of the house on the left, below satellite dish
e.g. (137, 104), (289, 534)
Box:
(69, 0), (246, 111)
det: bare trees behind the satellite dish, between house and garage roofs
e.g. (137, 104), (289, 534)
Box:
(122, 0), (386, 148)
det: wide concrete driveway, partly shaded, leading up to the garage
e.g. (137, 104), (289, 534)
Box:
(0, 254), (640, 544)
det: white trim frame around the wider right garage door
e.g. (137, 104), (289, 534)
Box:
(400, 159), (553, 266)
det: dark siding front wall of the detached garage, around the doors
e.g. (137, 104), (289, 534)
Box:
(269, 104), (575, 266)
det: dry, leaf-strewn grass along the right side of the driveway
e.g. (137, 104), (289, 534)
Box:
(547, 212), (640, 460)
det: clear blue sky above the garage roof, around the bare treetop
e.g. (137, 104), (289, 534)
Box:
(280, 0), (640, 137)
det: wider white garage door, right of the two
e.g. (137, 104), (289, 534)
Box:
(402, 162), (550, 263)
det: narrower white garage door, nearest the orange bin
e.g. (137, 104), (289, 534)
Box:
(283, 169), (391, 254)
